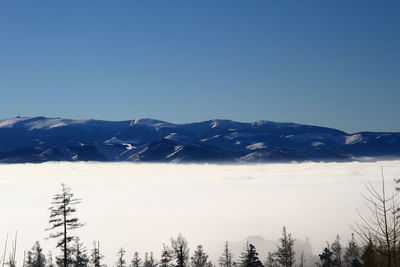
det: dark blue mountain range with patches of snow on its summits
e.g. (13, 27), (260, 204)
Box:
(0, 117), (400, 163)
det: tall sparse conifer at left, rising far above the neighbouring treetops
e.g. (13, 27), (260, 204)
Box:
(46, 184), (83, 267)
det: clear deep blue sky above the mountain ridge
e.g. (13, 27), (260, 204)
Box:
(0, 0), (400, 132)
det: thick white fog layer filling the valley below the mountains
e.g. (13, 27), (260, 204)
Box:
(0, 161), (400, 265)
